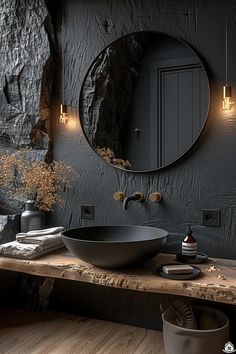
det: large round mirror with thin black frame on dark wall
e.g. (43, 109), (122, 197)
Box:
(80, 32), (210, 172)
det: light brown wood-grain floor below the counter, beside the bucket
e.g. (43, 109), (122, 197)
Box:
(0, 309), (164, 354)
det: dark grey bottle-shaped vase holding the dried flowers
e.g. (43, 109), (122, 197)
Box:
(21, 200), (45, 232)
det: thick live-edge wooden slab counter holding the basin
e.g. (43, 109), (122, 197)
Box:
(0, 249), (236, 305)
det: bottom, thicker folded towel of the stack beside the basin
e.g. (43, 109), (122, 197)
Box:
(0, 241), (64, 259)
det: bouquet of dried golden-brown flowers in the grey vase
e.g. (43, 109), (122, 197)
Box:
(0, 148), (78, 211)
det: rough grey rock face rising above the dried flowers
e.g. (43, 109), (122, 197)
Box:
(0, 0), (51, 149)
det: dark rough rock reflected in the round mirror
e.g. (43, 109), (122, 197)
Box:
(80, 35), (145, 157)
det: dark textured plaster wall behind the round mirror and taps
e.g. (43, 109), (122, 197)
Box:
(51, 0), (236, 258)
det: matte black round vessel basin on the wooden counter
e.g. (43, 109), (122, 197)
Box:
(62, 225), (168, 269)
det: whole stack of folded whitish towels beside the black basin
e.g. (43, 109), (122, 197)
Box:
(0, 226), (64, 259)
